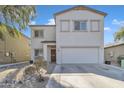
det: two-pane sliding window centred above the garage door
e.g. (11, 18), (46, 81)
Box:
(74, 21), (87, 31)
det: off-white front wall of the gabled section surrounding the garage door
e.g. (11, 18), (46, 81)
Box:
(56, 10), (104, 63)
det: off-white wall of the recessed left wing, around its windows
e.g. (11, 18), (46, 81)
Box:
(31, 25), (56, 60)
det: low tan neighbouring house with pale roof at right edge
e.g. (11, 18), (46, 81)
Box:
(104, 42), (124, 66)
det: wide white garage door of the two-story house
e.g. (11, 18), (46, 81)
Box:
(61, 48), (99, 64)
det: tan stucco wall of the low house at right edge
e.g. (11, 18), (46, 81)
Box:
(104, 45), (124, 62)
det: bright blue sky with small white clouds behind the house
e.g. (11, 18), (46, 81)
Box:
(24, 5), (124, 44)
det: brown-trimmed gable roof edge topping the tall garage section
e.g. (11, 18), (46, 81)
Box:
(54, 5), (107, 16)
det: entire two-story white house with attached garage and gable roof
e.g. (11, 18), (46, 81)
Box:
(30, 6), (106, 64)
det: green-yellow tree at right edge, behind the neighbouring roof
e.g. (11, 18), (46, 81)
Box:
(114, 27), (124, 41)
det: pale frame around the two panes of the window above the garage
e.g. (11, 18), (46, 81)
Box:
(73, 20), (88, 32)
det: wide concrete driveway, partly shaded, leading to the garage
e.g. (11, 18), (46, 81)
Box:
(46, 64), (124, 88)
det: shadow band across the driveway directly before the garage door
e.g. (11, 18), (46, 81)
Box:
(53, 64), (124, 81)
